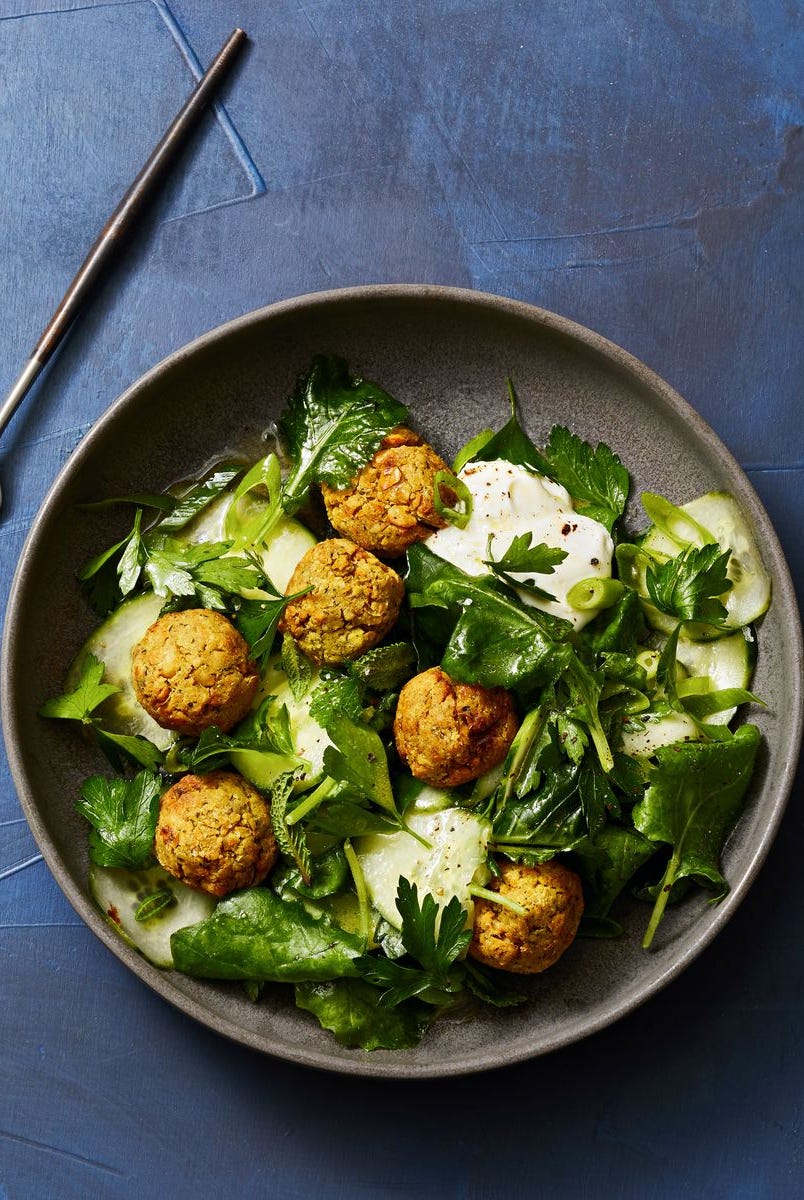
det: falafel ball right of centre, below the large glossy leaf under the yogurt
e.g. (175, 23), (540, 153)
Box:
(394, 667), (520, 787)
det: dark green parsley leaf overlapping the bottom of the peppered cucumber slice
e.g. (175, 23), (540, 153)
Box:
(358, 877), (472, 1008)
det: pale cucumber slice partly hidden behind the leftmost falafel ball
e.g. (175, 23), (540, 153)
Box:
(66, 592), (176, 750)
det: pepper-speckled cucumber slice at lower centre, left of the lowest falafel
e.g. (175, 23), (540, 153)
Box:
(355, 797), (491, 929)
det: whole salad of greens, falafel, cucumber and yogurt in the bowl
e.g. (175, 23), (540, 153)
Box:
(41, 356), (770, 1050)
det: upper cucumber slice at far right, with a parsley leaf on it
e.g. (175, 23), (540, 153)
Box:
(642, 492), (770, 641)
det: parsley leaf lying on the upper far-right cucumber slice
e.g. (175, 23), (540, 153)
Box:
(646, 542), (732, 625)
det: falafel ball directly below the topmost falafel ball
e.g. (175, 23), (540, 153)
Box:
(280, 538), (404, 666)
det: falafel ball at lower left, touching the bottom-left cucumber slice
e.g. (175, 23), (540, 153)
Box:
(154, 770), (280, 896)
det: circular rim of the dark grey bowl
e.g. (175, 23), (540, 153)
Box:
(0, 283), (804, 1079)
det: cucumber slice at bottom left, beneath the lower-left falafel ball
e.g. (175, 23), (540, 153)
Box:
(89, 865), (216, 967)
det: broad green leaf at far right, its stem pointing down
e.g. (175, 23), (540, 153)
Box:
(634, 725), (761, 949)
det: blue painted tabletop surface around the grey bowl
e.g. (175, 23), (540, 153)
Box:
(0, 0), (804, 1200)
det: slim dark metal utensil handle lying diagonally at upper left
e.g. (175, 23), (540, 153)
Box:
(0, 29), (247, 458)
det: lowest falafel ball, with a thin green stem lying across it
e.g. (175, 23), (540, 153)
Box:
(469, 860), (583, 974)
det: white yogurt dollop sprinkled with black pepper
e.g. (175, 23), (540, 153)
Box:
(427, 460), (614, 629)
